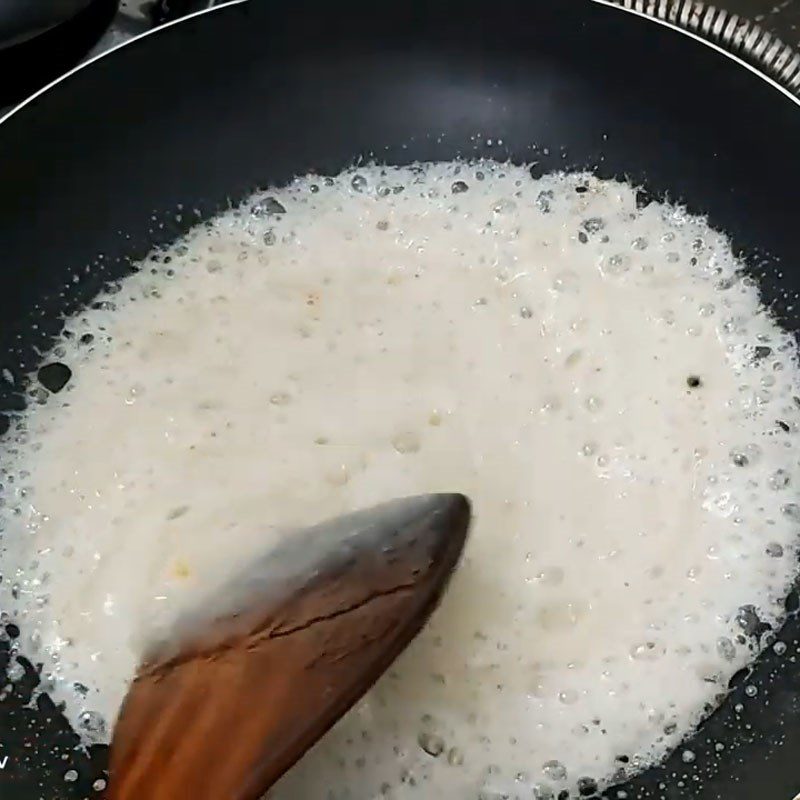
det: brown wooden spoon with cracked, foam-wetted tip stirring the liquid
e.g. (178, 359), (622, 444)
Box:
(107, 494), (470, 800)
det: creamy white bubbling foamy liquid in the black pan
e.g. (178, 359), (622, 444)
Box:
(0, 162), (800, 800)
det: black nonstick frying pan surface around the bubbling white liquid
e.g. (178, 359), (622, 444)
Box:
(0, 0), (800, 800)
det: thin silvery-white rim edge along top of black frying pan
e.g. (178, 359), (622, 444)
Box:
(0, 0), (800, 133)
